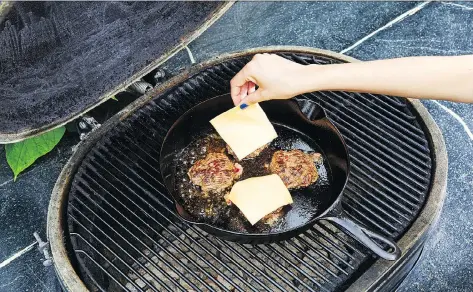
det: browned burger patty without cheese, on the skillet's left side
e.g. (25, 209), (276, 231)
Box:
(187, 153), (243, 193)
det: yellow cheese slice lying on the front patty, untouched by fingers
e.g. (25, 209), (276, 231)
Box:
(228, 174), (292, 225)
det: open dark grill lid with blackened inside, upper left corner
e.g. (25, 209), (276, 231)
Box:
(0, 1), (232, 143)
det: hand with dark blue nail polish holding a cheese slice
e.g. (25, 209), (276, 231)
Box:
(230, 53), (306, 105)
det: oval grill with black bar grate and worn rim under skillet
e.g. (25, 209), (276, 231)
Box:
(48, 47), (447, 291)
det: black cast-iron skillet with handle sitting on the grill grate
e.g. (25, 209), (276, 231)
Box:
(160, 95), (401, 260)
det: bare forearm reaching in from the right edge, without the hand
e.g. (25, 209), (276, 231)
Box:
(300, 55), (473, 102)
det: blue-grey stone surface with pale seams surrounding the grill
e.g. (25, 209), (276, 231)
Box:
(0, 2), (473, 291)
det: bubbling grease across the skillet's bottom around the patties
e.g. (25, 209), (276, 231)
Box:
(176, 125), (331, 233)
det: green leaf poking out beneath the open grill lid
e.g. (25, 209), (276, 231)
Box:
(5, 127), (66, 181)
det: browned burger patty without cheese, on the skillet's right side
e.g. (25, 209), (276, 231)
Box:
(269, 150), (322, 189)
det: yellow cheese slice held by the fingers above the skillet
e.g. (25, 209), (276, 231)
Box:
(210, 104), (278, 160)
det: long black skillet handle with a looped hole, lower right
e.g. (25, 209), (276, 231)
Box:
(323, 216), (401, 261)
